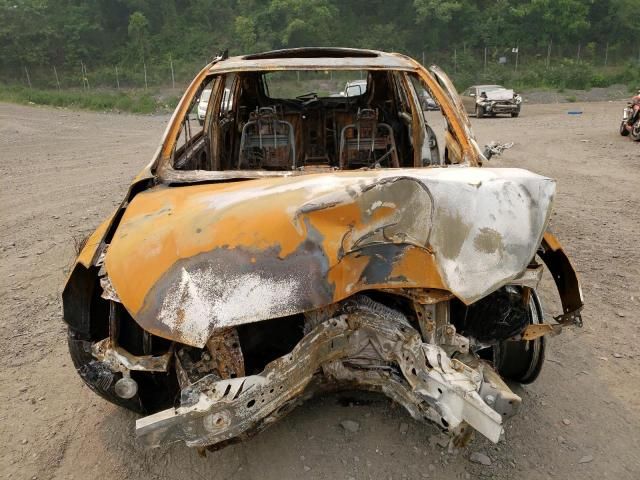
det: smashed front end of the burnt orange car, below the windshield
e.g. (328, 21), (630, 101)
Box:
(64, 168), (582, 449)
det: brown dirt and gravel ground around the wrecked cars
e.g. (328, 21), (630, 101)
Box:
(0, 102), (640, 480)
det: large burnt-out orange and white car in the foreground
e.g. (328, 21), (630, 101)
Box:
(63, 48), (583, 449)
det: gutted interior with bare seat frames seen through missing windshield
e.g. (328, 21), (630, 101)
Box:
(173, 70), (440, 171)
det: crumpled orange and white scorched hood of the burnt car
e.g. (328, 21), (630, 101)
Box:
(105, 167), (555, 347)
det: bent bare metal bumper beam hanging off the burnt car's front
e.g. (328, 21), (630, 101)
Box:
(136, 297), (520, 447)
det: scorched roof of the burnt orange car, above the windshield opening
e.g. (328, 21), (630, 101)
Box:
(210, 47), (416, 73)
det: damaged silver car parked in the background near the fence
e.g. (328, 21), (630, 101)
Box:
(462, 85), (522, 118)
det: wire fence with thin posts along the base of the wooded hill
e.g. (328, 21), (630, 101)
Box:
(5, 43), (640, 92)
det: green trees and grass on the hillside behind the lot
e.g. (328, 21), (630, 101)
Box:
(0, 0), (640, 94)
